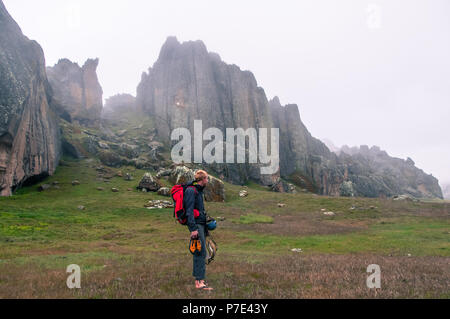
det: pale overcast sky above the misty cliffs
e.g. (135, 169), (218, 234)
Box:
(4, 0), (450, 189)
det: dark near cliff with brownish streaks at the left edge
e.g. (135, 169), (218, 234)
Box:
(0, 1), (60, 196)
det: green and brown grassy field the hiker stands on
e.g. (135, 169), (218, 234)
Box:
(0, 159), (450, 298)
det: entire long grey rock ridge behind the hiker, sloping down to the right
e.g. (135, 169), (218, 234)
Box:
(136, 37), (442, 198)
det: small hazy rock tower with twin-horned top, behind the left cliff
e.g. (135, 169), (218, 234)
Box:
(47, 59), (103, 127)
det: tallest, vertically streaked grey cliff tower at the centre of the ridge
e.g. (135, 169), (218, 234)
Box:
(136, 37), (279, 185)
